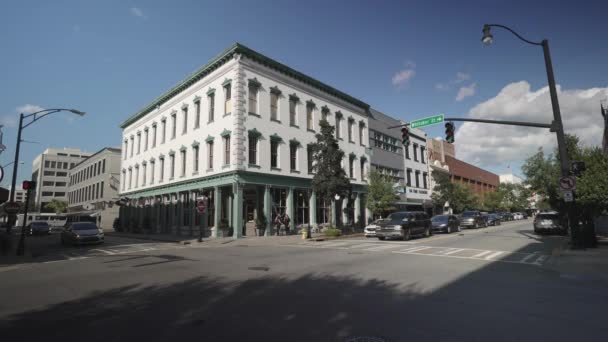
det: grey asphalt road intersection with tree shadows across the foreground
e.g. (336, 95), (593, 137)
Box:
(0, 220), (608, 341)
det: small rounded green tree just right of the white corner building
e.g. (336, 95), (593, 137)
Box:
(367, 170), (397, 217)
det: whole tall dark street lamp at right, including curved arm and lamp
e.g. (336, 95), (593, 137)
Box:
(481, 24), (579, 246)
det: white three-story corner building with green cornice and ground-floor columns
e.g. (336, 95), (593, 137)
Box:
(120, 44), (370, 237)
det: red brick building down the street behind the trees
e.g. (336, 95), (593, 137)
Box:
(445, 156), (500, 196)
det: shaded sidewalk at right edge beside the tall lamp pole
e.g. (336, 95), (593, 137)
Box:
(548, 236), (608, 282)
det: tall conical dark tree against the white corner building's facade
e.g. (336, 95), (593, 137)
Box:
(312, 120), (351, 226)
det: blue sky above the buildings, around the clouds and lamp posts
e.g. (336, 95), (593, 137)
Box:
(0, 0), (608, 184)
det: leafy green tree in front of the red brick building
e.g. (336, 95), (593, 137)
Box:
(431, 172), (478, 213)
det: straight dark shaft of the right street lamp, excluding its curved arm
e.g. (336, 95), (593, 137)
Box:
(541, 39), (581, 247)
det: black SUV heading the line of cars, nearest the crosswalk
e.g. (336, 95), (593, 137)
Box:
(376, 211), (433, 240)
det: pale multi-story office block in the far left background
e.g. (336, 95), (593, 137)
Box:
(32, 148), (91, 212)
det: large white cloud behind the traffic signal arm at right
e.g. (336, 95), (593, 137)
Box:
(455, 81), (608, 167)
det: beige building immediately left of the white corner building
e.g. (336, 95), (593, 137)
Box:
(68, 147), (121, 230)
